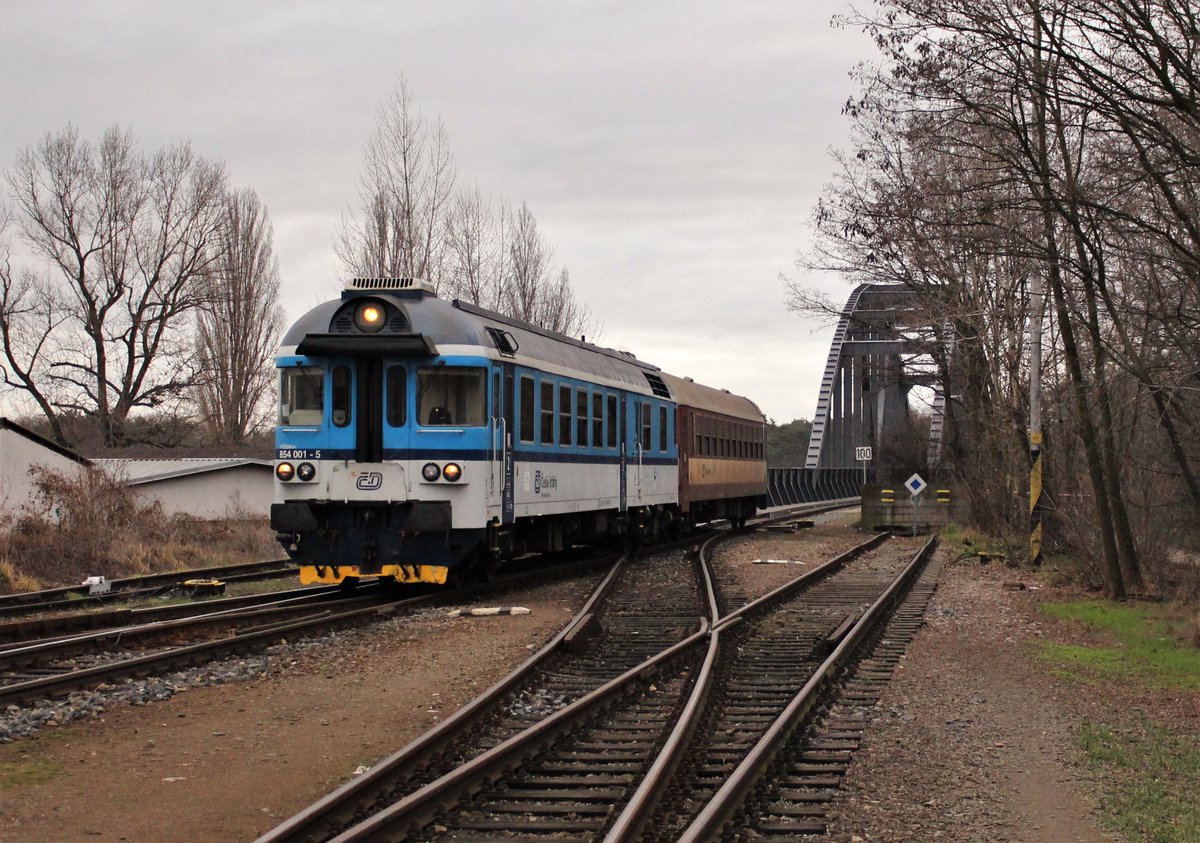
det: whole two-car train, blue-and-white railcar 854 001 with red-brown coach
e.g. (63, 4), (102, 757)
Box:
(271, 279), (767, 586)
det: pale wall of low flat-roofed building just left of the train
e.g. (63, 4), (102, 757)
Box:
(130, 465), (275, 519)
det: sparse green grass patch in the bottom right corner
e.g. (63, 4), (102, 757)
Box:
(1078, 719), (1200, 843)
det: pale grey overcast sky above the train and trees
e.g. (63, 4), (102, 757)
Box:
(0, 0), (871, 422)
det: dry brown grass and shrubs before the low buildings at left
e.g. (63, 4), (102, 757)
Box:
(0, 468), (280, 592)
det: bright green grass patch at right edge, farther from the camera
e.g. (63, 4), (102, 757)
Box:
(1039, 600), (1200, 690)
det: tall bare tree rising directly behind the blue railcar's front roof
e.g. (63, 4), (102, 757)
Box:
(334, 77), (456, 286)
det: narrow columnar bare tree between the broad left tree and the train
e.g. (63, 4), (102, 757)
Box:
(196, 189), (283, 443)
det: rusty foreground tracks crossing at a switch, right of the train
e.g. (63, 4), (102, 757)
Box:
(260, 509), (928, 842)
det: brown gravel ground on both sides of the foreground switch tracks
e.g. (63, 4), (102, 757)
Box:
(0, 516), (1152, 843)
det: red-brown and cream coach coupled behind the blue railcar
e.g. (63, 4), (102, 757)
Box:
(662, 373), (767, 526)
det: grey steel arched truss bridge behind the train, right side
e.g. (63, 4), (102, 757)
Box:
(767, 283), (946, 506)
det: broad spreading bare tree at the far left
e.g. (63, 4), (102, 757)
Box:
(0, 126), (224, 444)
